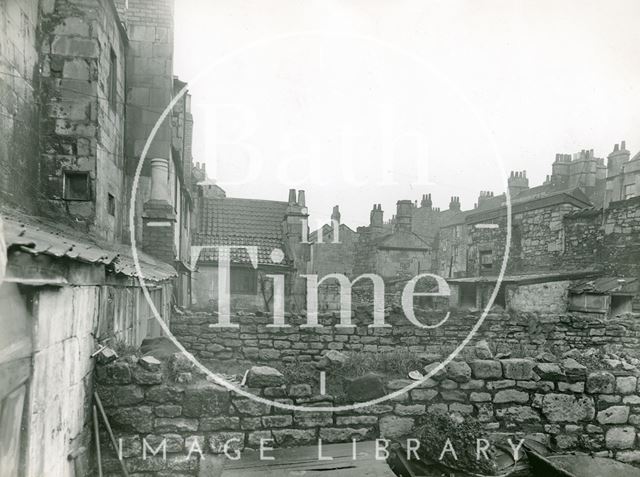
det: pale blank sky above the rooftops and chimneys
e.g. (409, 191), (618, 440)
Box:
(174, 0), (640, 228)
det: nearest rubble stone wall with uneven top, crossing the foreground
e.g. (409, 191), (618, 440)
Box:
(97, 349), (640, 476)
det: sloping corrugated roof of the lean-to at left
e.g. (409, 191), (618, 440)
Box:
(2, 213), (177, 281)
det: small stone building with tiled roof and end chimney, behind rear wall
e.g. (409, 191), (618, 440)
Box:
(192, 186), (309, 311)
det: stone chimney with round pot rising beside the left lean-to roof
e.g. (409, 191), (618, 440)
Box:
(142, 158), (176, 265)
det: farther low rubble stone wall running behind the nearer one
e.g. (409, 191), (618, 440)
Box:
(171, 311), (640, 362)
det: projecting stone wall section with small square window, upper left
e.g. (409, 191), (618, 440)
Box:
(39, 0), (127, 240)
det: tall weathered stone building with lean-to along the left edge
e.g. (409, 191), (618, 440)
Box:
(0, 0), (192, 477)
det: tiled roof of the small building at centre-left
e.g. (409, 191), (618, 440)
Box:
(193, 197), (287, 264)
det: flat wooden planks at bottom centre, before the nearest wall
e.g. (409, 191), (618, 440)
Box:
(222, 441), (394, 477)
